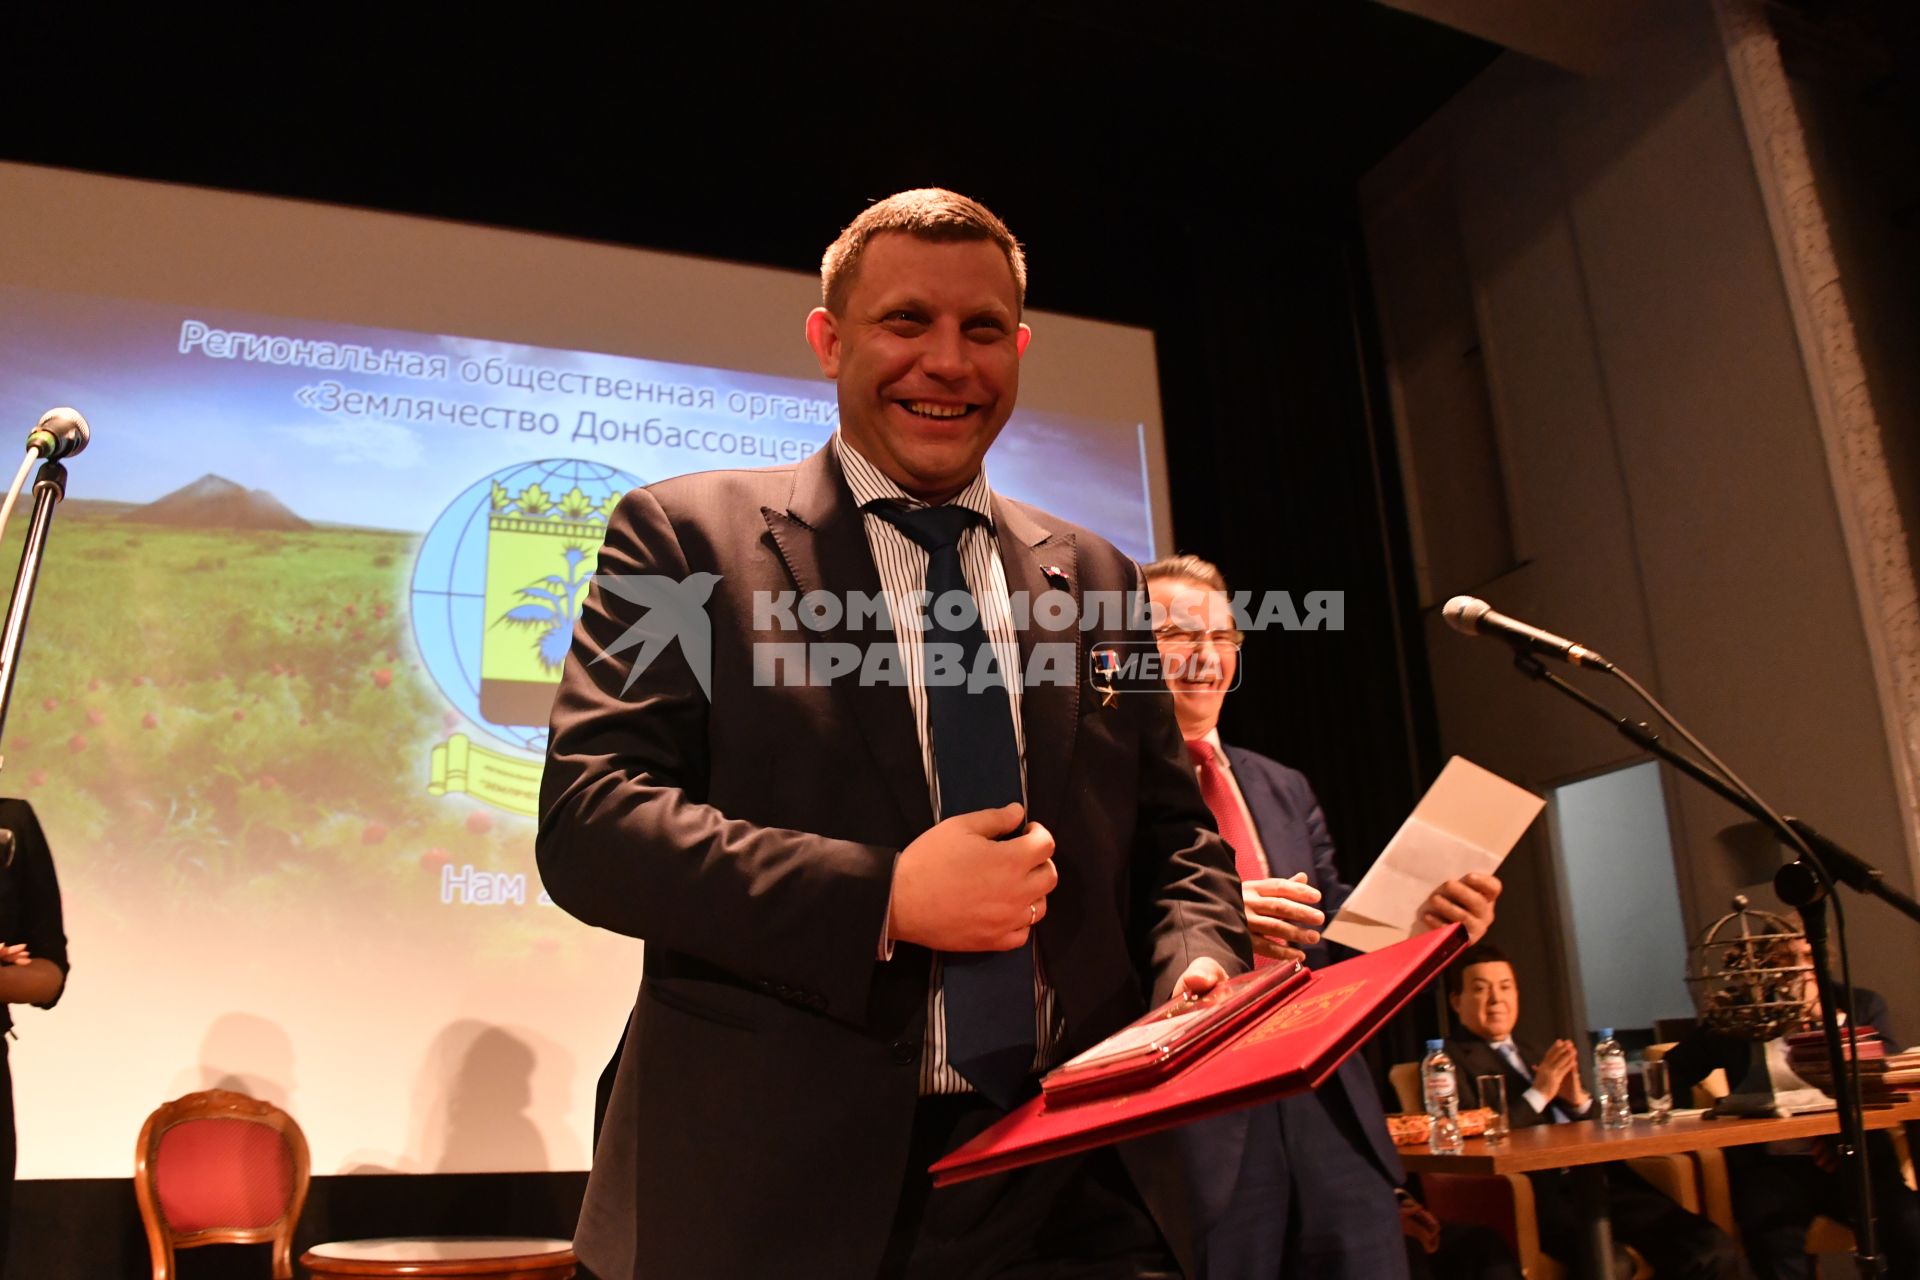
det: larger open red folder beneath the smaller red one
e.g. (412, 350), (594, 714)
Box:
(931, 925), (1467, 1186)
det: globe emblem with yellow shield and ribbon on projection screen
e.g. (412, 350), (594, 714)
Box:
(411, 459), (645, 814)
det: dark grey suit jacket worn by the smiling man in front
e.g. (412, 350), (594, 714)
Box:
(538, 449), (1250, 1280)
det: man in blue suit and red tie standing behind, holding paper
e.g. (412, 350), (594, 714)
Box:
(1146, 557), (1500, 1280)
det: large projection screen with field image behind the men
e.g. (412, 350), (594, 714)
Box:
(0, 165), (1169, 1178)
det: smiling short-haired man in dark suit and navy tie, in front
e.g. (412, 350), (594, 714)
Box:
(538, 190), (1252, 1280)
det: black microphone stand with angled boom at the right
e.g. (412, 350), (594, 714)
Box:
(1513, 643), (1889, 1278)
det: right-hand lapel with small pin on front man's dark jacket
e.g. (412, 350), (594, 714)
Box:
(993, 495), (1083, 829)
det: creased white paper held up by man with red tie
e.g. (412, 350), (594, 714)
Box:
(1321, 756), (1546, 952)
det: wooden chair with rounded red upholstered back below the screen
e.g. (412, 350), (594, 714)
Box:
(132, 1090), (309, 1280)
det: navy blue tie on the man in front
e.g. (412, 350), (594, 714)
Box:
(872, 505), (1035, 1107)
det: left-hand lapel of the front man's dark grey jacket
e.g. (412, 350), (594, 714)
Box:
(760, 449), (933, 839)
